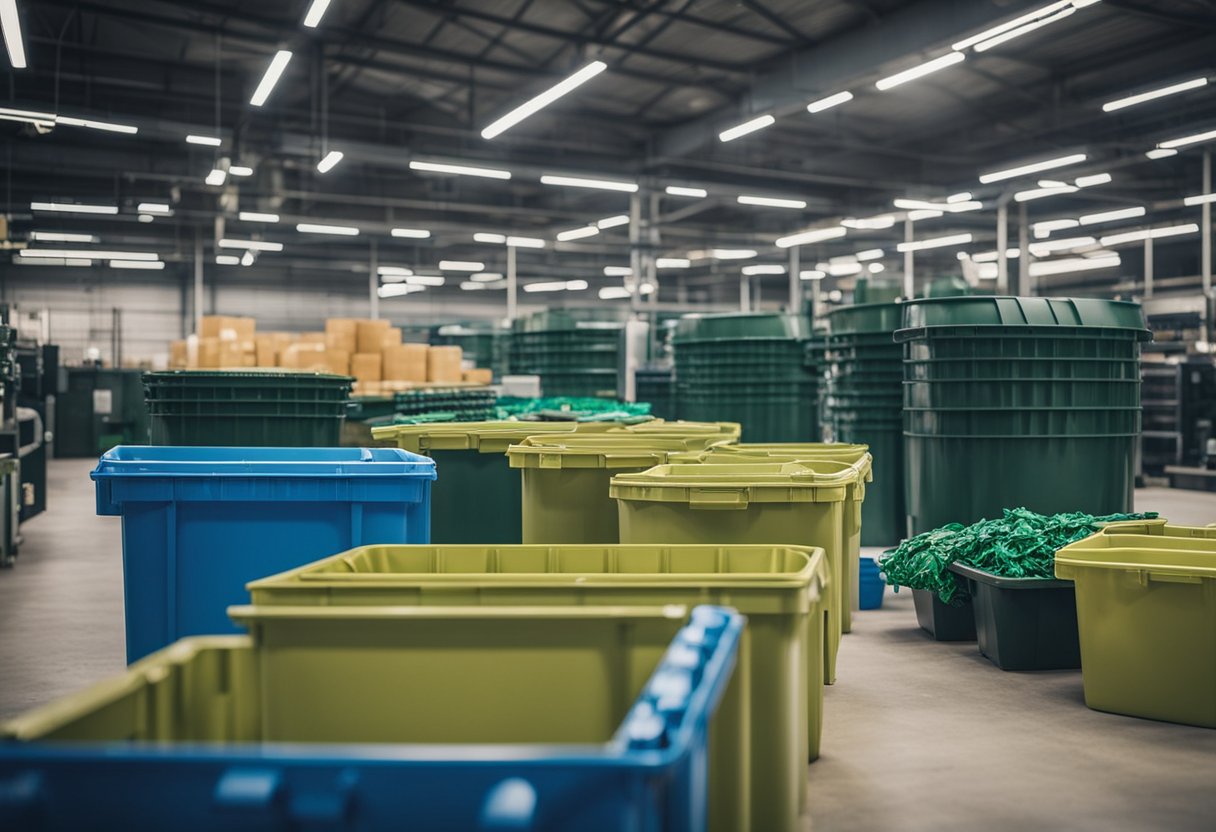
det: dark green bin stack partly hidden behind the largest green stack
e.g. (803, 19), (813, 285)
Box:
(824, 303), (906, 546)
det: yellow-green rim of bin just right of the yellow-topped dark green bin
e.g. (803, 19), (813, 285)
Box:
(507, 432), (730, 468)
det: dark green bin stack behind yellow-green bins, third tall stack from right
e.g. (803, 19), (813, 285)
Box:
(674, 314), (821, 442)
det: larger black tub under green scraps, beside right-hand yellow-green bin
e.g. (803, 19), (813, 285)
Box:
(948, 563), (1081, 670)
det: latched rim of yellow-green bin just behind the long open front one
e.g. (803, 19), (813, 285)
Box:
(609, 462), (860, 508)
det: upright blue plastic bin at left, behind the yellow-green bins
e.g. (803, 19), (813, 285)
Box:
(92, 445), (435, 662)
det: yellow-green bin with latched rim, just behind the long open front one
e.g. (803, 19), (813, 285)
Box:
(609, 462), (857, 690)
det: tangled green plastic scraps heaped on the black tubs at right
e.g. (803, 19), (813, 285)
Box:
(879, 508), (1156, 606)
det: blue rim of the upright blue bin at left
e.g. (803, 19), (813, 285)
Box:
(90, 445), (435, 480)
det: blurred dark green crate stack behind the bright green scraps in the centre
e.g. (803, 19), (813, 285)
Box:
(511, 309), (624, 398)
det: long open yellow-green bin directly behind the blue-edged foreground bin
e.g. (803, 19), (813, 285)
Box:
(249, 545), (831, 832)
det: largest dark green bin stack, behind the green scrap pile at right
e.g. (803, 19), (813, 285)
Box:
(904, 296), (1152, 534)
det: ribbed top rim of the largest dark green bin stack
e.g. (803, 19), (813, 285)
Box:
(895, 294), (1152, 341)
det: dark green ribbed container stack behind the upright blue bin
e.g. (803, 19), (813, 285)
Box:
(143, 370), (354, 448)
